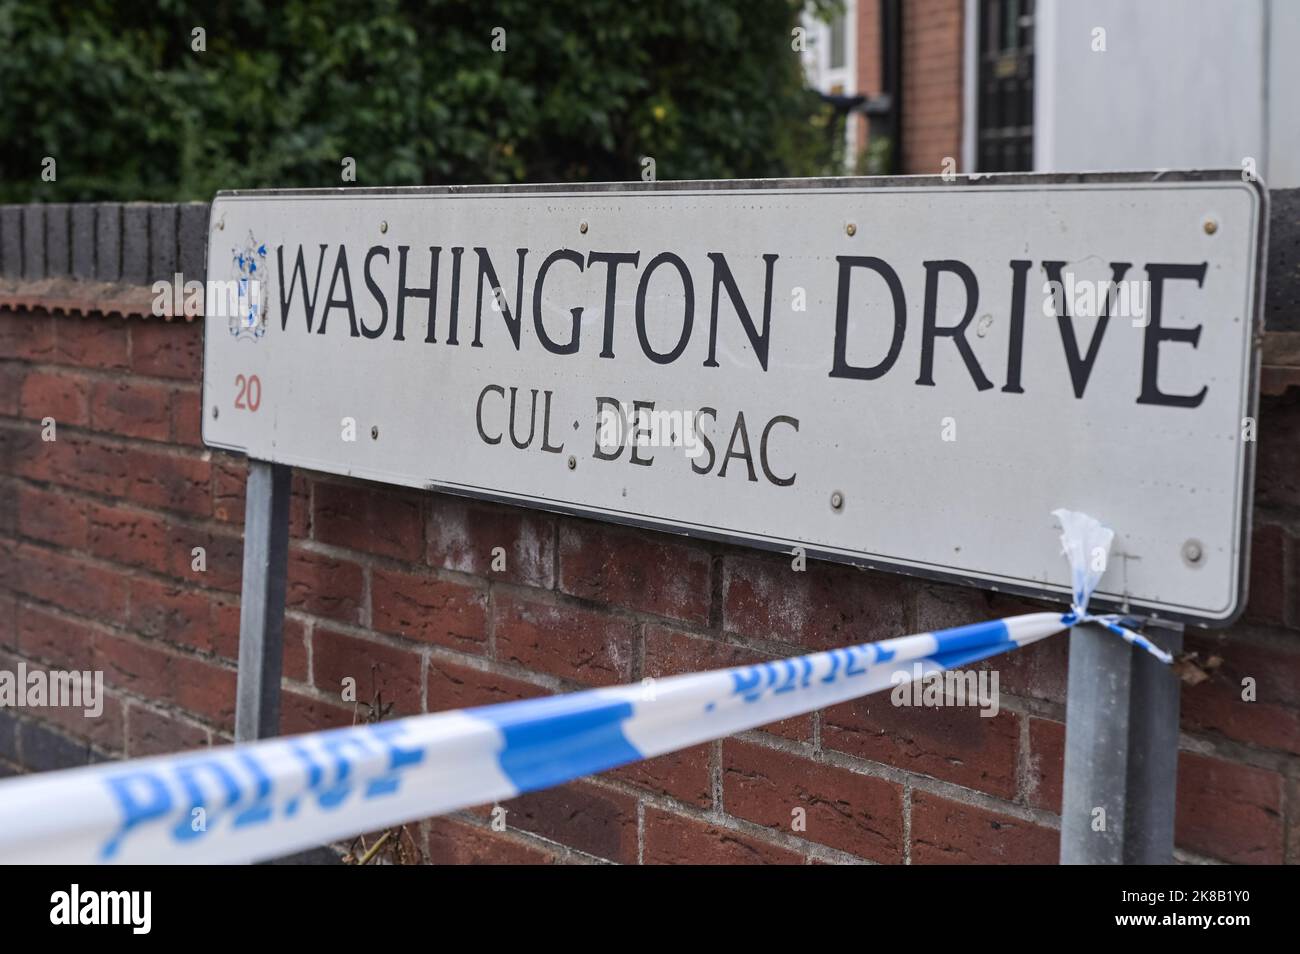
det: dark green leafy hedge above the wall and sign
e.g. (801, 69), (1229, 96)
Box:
(0, 0), (840, 201)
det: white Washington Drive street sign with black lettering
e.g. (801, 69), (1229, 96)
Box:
(203, 172), (1266, 624)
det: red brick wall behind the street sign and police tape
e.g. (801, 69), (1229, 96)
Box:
(0, 204), (1300, 863)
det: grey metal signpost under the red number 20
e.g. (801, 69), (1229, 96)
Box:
(235, 460), (293, 742)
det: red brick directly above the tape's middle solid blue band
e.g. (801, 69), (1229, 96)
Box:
(491, 590), (637, 686)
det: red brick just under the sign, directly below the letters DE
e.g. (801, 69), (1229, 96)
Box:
(559, 520), (712, 623)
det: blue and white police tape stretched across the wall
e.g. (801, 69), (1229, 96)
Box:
(0, 612), (1073, 863)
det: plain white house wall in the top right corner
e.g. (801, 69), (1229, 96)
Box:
(1034, 0), (1300, 188)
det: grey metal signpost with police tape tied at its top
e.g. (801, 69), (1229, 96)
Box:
(1061, 624), (1183, 864)
